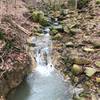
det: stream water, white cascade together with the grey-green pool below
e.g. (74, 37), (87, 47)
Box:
(9, 28), (73, 100)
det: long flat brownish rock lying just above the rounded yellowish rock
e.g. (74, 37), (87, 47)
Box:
(74, 57), (91, 65)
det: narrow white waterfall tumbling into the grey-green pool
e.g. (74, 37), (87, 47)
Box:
(33, 28), (54, 76)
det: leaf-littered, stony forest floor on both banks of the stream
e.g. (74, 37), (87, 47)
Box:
(0, 0), (100, 100)
